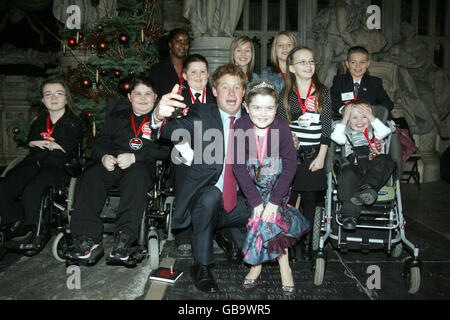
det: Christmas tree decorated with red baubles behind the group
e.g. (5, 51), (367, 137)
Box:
(16, 0), (166, 149)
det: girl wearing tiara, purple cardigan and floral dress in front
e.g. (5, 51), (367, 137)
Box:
(233, 79), (310, 295)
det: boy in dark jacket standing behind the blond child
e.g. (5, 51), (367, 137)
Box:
(330, 47), (394, 113)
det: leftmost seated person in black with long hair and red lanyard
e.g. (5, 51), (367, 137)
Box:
(0, 81), (83, 250)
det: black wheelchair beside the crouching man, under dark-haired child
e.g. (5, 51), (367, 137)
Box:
(53, 99), (175, 269)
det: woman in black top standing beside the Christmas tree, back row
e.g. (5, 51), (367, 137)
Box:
(150, 28), (190, 97)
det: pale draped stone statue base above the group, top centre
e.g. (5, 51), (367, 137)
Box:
(183, 0), (244, 38)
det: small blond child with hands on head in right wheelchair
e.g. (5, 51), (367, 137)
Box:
(331, 100), (395, 231)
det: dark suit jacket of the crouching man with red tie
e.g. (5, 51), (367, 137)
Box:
(160, 103), (232, 229)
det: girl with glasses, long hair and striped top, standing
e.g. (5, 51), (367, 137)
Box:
(278, 47), (332, 260)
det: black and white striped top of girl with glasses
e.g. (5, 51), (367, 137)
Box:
(277, 87), (333, 147)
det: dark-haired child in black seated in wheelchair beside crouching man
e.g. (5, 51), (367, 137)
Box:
(69, 77), (163, 264)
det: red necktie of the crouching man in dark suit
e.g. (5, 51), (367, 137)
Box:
(222, 116), (237, 213)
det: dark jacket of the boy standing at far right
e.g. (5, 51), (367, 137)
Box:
(330, 72), (394, 113)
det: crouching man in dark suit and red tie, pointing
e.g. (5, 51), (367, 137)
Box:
(152, 64), (248, 292)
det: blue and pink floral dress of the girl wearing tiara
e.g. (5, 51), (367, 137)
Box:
(242, 158), (311, 265)
